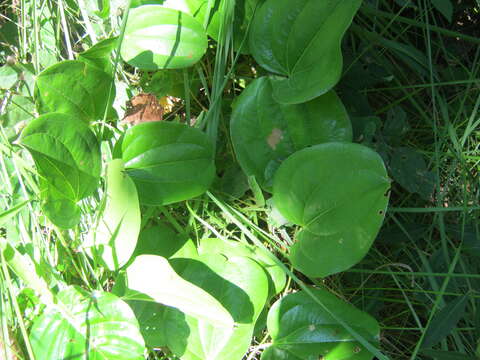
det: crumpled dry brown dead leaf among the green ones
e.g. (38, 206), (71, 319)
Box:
(122, 93), (163, 125)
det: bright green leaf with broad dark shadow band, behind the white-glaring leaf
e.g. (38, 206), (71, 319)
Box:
(163, 254), (268, 360)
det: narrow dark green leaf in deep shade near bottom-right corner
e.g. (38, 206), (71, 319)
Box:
(422, 295), (469, 348)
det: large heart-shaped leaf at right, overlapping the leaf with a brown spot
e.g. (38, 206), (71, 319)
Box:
(273, 143), (390, 277)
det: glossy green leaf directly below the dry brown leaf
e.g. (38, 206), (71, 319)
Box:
(122, 122), (215, 205)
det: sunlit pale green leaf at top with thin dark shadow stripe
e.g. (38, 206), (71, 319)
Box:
(121, 5), (207, 70)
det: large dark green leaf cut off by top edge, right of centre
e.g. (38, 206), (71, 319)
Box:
(250, 0), (362, 104)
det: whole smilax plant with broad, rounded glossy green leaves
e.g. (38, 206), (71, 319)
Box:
(2, 0), (390, 360)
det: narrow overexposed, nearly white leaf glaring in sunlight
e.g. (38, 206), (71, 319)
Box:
(127, 255), (233, 328)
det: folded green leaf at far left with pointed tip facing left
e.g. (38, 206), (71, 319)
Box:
(20, 113), (102, 228)
